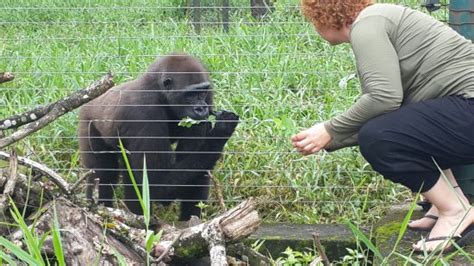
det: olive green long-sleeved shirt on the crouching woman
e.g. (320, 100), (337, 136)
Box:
(324, 4), (474, 151)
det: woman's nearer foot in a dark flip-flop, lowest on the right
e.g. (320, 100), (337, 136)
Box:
(413, 206), (474, 252)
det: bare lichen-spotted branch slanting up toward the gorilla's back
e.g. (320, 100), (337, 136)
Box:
(0, 73), (114, 149)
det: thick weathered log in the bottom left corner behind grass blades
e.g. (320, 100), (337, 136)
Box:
(10, 198), (145, 265)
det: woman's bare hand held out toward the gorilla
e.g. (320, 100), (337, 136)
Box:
(291, 123), (331, 155)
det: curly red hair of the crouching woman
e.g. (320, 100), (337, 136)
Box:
(301, 0), (373, 30)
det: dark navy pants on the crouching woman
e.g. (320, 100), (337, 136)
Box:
(359, 96), (474, 192)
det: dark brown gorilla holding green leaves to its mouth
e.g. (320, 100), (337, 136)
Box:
(79, 54), (239, 220)
